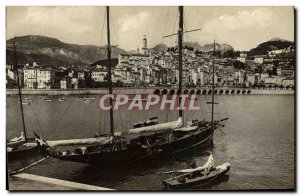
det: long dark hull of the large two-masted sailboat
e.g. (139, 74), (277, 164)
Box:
(54, 127), (214, 167)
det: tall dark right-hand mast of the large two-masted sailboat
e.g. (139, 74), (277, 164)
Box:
(178, 6), (183, 117)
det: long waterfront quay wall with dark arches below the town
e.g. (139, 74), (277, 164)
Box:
(6, 87), (294, 95)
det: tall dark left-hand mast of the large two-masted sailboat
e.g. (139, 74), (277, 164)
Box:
(106, 6), (114, 136)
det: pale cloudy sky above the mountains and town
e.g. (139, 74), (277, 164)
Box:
(6, 6), (294, 51)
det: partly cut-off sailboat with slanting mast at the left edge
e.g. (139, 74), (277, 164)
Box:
(6, 39), (37, 159)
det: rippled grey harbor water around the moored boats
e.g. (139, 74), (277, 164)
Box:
(6, 95), (295, 190)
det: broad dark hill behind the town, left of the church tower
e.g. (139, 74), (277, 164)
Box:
(6, 35), (127, 66)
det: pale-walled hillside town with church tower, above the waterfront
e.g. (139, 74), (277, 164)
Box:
(6, 36), (295, 89)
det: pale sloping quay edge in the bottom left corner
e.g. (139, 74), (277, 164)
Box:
(8, 173), (114, 191)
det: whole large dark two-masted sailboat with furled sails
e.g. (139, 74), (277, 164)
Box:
(36, 6), (227, 167)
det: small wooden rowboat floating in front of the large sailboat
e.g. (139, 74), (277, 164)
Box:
(163, 162), (230, 189)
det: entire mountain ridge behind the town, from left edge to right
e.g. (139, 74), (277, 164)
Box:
(6, 35), (294, 66)
